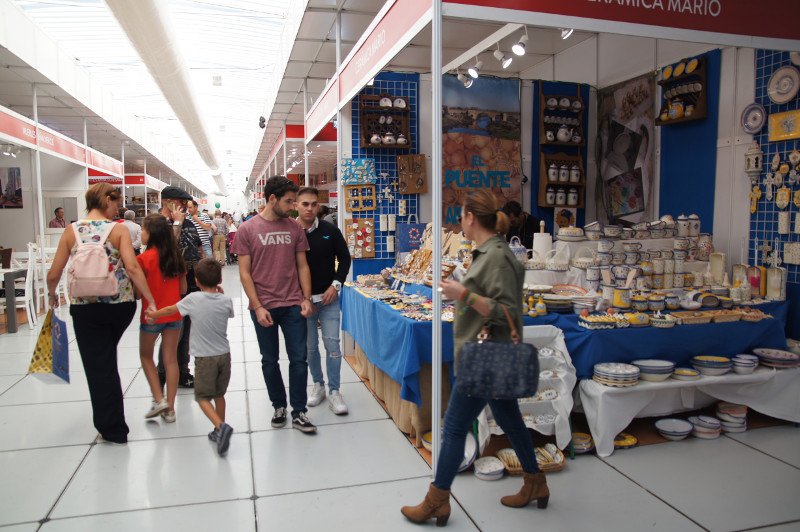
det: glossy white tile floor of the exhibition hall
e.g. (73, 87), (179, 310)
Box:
(0, 268), (800, 532)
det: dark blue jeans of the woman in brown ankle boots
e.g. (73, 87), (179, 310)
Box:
(433, 388), (539, 490)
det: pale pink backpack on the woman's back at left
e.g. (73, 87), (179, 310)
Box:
(67, 223), (119, 297)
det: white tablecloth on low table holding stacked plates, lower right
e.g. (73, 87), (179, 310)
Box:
(579, 367), (800, 456)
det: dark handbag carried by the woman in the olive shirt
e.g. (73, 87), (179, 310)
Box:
(456, 305), (539, 399)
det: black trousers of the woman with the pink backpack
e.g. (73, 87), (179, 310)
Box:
(69, 302), (136, 443)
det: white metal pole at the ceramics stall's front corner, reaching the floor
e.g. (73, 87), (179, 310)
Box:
(431, 0), (442, 477)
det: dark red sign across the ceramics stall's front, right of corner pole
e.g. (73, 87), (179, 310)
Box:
(444, 0), (800, 40)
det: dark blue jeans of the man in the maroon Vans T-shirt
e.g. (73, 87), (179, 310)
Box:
(250, 305), (308, 417)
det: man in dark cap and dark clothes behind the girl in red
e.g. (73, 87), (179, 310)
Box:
(158, 186), (203, 388)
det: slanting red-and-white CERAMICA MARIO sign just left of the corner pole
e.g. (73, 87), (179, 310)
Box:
(340, 0), (433, 105)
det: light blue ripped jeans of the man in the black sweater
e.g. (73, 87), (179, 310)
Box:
(306, 297), (342, 392)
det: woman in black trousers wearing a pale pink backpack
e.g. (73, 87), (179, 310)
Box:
(47, 183), (158, 444)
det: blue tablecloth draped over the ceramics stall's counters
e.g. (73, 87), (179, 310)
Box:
(341, 286), (789, 404)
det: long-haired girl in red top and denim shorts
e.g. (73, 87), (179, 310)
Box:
(136, 214), (186, 423)
